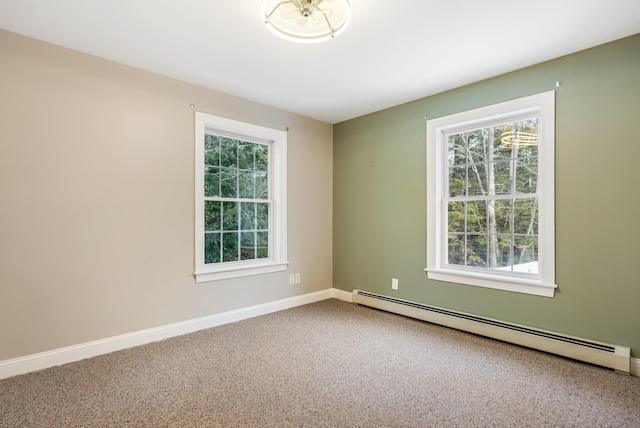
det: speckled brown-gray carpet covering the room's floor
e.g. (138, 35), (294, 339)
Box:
(0, 300), (640, 428)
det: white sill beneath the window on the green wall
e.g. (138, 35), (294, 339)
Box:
(425, 269), (558, 297)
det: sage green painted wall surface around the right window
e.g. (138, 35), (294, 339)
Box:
(333, 34), (640, 357)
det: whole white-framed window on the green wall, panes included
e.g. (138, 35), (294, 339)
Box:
(426, 91), (556, 297)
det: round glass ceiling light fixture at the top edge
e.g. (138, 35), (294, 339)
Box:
(262, 0), (351, 43)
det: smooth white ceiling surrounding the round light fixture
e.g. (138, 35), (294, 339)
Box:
(0, 0), (640, 123)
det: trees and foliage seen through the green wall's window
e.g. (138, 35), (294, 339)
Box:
(447, 118), (540, 270)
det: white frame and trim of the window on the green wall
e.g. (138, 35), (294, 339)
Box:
(425, 91), (557, 297)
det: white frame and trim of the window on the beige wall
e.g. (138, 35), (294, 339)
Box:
(194, 112), (289, 282)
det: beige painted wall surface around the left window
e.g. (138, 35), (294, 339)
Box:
(0, 31), (333, 361)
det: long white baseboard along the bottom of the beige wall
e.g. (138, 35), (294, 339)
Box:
(0, 288), (340, 379)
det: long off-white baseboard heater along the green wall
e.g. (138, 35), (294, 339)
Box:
(352, 290), (631, 374)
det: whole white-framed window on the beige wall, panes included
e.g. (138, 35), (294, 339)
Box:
(195, 112), (287, 282)
